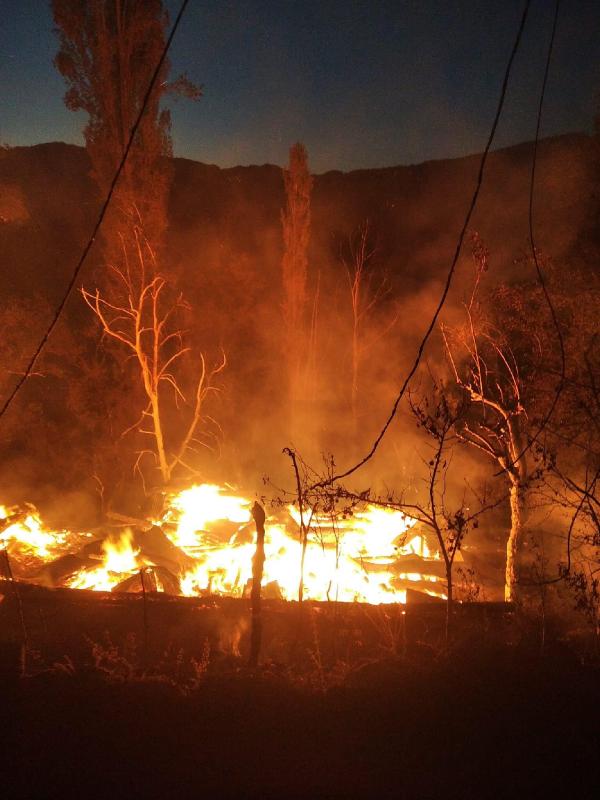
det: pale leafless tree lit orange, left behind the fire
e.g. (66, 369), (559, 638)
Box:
(82, 229), (226, 484)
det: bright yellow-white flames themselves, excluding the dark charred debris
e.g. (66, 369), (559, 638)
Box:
(0, 484), (444, 604)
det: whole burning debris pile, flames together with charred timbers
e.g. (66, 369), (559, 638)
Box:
(0, 484), (445, 604)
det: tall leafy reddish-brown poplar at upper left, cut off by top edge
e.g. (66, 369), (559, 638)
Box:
(52, 0), (200, 256)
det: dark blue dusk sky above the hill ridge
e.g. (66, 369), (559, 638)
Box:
(0, 0), (600, 172)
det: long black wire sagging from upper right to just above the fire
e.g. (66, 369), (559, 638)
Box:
(313, 0), (531, 488)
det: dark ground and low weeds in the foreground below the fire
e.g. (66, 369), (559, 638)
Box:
(0, 588), (600, 798)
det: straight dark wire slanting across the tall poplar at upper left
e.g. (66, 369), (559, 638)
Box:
(0, 0), (189, 419)
